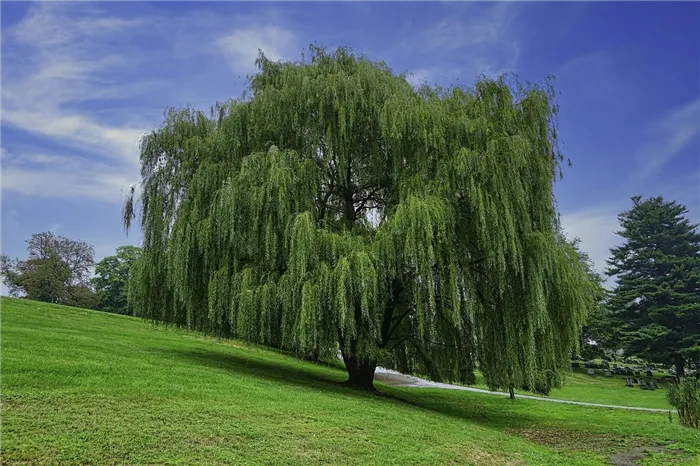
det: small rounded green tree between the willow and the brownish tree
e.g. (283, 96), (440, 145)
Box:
(92, 246), (141, 314)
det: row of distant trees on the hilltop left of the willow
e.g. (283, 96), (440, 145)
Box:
(0, 231), (141, 314)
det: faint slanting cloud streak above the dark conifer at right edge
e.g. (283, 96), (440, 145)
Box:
(632, 98), (700, 181)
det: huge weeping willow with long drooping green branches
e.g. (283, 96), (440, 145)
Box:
(124, 48), (591, 388)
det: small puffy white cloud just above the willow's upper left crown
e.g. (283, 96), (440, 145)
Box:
(217, 25), (298, 71)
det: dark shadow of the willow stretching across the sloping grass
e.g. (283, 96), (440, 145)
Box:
(158, 349), (537, 430)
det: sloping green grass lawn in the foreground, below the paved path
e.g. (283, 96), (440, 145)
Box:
(0, 298), (700, 465)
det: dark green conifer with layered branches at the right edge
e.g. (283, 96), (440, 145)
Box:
(607, 196), (700, 376)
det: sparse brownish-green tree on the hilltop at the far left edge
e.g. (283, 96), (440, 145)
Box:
(0, 232), (97, 308)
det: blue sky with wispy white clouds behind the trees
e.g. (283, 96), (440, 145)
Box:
(0, 0), (700, 292)
